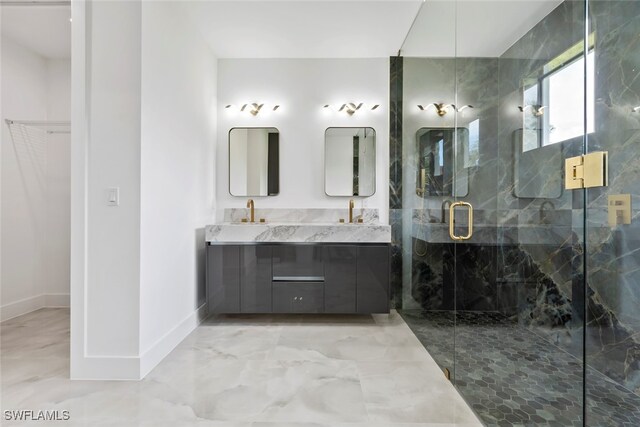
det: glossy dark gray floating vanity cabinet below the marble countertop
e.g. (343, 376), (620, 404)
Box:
(206, 243), (389, 314)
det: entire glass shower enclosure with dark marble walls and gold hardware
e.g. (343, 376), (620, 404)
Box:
(390, 0), (640, 426)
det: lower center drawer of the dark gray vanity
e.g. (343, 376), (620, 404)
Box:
(273, 282), (324, 313)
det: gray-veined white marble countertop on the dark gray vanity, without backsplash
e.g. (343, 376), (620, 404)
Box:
(206, 222), (391, 243)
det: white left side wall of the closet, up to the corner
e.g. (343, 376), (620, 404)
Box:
(0, 36), (47, 320)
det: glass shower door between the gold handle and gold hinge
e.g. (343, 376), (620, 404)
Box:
(453, 1), (593, 426)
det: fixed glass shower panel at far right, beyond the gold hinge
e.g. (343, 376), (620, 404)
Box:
(585, 0), (640, 426)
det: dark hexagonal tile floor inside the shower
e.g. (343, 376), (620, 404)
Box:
(401, 310), (640, 427)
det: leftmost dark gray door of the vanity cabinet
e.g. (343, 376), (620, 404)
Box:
(206, 245), (240, 313)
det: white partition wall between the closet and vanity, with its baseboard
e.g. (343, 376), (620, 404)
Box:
(71, 0), (216, 379)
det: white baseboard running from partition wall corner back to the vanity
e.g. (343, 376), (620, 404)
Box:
(140, 304), (207, 378)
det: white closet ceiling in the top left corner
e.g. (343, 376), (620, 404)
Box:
(0, 2), (71, 59)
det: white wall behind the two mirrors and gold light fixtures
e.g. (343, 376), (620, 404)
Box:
(216, 58), (389, 222)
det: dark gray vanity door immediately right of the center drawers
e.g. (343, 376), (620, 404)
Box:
(324, 245), (357, 313)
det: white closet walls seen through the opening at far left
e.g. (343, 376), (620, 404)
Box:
(0, 36), (71, 320)
